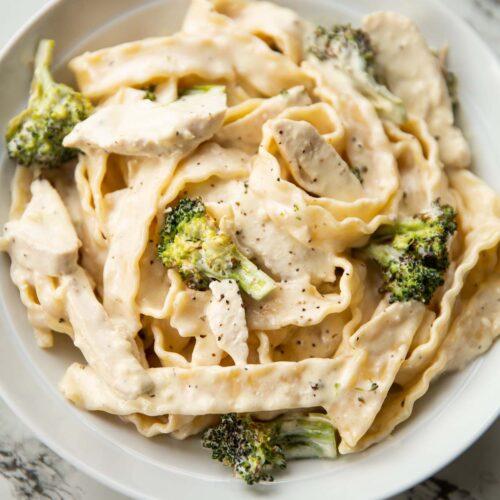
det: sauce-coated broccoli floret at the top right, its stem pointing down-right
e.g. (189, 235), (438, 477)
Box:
(308, 24), (406, 124)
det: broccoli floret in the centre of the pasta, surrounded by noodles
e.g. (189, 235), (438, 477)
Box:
(158, 198), (276, 300)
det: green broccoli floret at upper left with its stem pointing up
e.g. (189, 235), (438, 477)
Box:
(5, 40), (92, 167)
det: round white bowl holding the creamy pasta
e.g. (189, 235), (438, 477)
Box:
(0, 0), (500, 500)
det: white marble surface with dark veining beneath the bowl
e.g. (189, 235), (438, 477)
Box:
(0, 0), (500, 500)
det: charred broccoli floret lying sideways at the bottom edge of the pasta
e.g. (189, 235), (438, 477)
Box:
(202, 413), (337, 484)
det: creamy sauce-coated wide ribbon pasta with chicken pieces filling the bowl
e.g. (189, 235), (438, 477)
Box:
(0, 0), (500, 472)
